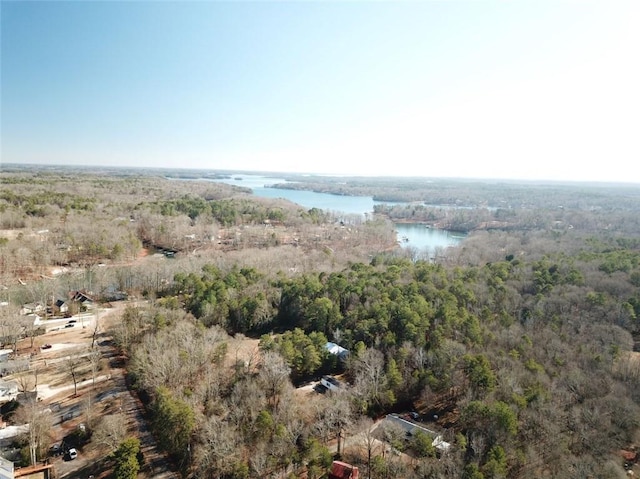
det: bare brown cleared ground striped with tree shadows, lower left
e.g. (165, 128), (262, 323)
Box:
(5, 302), (177, 478)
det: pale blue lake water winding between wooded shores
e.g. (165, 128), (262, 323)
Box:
(212, 174), (464, 256)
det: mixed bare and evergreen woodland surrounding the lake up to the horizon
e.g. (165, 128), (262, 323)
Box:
(0, 168), (640, 479)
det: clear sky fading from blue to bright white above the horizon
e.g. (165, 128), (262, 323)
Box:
(0, 0), (640, 183)
